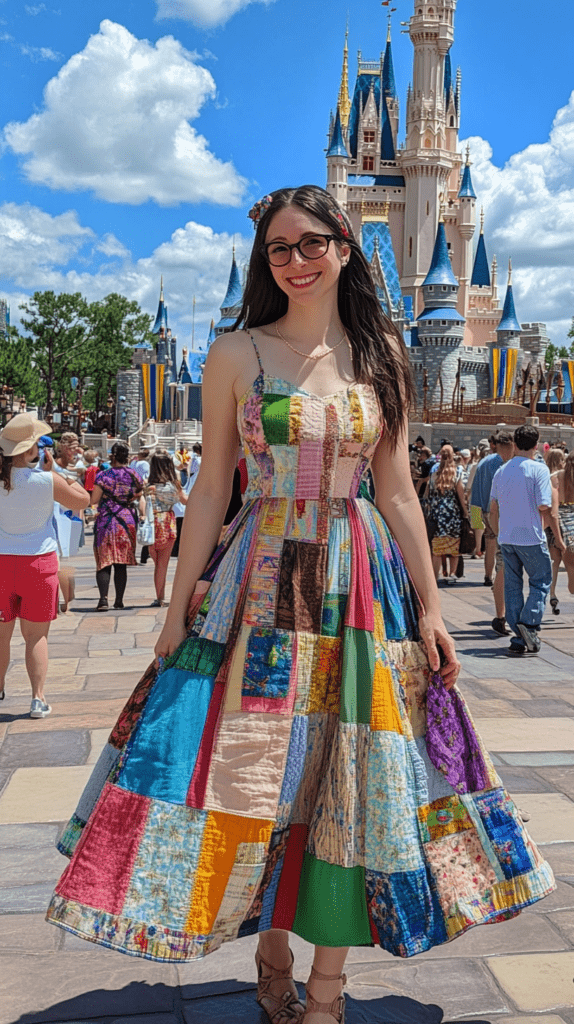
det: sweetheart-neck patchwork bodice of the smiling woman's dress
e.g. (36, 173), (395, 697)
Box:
(237, 343), (383, 501)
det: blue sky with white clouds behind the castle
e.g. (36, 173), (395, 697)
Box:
(0, 0), (574, 352)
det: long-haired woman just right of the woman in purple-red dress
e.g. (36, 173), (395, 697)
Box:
(145, 449), (187, 608)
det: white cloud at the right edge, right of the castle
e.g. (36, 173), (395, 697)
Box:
(463, 92), (574, 344)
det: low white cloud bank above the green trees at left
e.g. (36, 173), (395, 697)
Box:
(0, 203), (252, 346)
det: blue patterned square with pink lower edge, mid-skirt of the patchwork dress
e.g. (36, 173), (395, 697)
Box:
(241, 627), (294, 699)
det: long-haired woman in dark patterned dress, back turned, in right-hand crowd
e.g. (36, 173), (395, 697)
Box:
(429, 444), (467, 584)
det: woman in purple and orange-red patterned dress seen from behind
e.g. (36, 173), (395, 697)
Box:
(92, 441), (143, 611)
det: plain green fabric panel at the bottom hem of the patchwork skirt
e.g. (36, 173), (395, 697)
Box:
(292, 853), (372, 946)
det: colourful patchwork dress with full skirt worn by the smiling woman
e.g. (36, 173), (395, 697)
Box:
(48, 339), (555, 961)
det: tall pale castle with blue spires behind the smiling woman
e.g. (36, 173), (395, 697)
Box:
(326, 0), (549, 403)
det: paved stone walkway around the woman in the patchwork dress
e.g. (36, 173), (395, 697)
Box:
(0, 548), (574, 1024)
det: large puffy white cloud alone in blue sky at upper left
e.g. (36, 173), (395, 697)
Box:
(4, 20), (247, 206)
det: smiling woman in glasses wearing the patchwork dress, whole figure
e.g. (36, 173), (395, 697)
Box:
(48, 185), (553, 1024)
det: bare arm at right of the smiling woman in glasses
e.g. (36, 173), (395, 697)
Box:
(371, 421), (460, 689)
